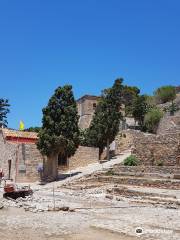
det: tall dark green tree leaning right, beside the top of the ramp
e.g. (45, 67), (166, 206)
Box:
(87, 79), (123, 159)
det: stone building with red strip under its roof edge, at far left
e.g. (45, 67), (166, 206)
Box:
(0, 128), (43, 182)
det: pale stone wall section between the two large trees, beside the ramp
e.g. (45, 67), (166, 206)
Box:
(69, 146), (99, 169)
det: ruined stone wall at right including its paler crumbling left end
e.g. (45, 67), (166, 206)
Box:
(116, 130), (180, 166)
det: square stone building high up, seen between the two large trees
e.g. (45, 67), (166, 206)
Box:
(77, 95), (100, 129)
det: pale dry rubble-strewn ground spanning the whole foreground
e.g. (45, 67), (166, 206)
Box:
(0, 153), (180, 240)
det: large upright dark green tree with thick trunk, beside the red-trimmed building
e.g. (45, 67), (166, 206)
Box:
(37, 85), (79, 179)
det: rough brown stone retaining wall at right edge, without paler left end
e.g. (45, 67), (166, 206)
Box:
(132, 134), (180, 166)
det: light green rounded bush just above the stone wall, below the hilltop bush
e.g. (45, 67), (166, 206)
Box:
(144, 108), (163, 133)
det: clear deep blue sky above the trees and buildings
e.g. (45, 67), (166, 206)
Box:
(0, 0), (180, 128)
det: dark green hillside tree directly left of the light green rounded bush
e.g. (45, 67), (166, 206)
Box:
(132, 95), (148, 128)
